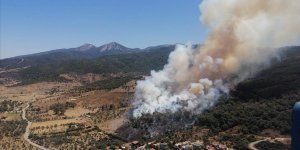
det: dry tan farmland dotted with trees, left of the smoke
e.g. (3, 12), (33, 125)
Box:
(0, 69), (136, 149)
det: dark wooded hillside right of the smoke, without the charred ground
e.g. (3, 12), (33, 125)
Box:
(197, 47), (300, 135)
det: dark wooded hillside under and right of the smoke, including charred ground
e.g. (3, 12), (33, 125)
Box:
(118, 46), (300, 142)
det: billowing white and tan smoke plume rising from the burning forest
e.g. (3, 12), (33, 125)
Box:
(133, 0), (300, 117)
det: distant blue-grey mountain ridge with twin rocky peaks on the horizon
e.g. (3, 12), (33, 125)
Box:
(0, 42), (175, 69)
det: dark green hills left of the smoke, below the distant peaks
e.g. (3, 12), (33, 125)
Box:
(1, 45), (175, 85)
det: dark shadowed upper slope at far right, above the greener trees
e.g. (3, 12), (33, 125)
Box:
(233, 47), (300, 99)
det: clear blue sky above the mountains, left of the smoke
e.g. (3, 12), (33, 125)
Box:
(0, 0), (208, 58)
